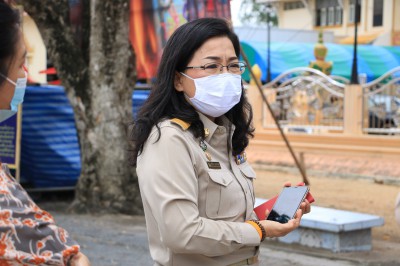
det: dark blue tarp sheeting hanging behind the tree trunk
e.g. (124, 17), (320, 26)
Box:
(20, 86), (149, 188)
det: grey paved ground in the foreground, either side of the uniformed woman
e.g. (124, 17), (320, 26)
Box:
(47, 211), (400, 266)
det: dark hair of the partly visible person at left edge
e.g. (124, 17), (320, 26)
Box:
(0, 0), (21, 85)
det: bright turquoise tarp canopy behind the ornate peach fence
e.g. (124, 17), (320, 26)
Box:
(241, 41), (400, 81)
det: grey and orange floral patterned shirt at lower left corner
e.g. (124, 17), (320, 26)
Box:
(0, 163), (80, 266)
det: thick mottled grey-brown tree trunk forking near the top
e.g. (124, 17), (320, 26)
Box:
(22, 0), (142, 214)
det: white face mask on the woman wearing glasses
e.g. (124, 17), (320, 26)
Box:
(181, 72), (242, 117)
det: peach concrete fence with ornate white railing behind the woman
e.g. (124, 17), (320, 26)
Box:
(247, 68), (400, 158)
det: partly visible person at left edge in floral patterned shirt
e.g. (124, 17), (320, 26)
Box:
(0, 0), (90, 266)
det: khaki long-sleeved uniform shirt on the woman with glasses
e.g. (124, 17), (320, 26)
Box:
(137, 114), (260, 266)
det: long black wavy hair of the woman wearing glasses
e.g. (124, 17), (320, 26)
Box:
(129, 18), (254, 166)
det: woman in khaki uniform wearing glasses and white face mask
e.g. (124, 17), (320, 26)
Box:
(131, 18), (310, 266)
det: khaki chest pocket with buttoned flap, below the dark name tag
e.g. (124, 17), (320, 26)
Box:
(206, 169), (244, 219)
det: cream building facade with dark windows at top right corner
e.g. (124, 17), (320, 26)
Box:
(258, 0), (400, 45)
